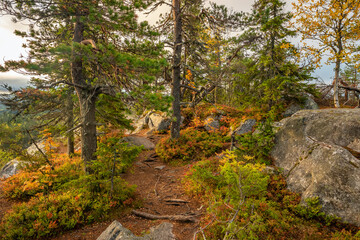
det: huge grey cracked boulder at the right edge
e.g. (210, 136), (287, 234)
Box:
(271, 109), (360, 226)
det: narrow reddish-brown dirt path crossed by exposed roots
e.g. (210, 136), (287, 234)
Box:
(119, 148), (202, 240)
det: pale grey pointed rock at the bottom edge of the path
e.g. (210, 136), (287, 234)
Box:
(97, 220), (175, 240)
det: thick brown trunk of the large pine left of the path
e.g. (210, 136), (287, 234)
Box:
(71, 16), (97, 173)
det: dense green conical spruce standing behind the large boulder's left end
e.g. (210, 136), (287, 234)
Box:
(235, 0), (310, 114)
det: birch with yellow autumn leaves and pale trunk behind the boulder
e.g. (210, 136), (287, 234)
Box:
(293, 0), (360, 107)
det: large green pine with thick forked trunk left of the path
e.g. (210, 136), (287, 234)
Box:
(0, 0), (166, 172)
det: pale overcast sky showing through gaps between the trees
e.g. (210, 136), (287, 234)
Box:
(0, 0), (334, 90)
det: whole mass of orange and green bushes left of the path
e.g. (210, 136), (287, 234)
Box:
(0, 131), (141, 239)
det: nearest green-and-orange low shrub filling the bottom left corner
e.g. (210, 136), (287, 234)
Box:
(0, 181), (134, 239)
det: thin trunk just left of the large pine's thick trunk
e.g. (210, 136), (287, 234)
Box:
(66, 87), (75, 157)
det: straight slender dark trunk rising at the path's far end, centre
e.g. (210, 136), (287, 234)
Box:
(171, 0), (182, 138)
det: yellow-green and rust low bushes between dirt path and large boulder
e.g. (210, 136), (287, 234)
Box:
(184, 151), (358, 239)
